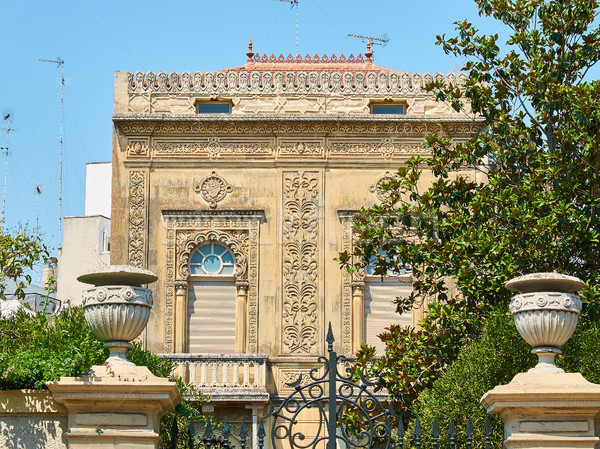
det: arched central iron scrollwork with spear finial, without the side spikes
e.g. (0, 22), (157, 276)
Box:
(265, 323), (398, 449)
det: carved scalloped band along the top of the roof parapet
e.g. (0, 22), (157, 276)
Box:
(127, 70), (466, 96)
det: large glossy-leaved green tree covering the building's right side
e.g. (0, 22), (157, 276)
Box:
(340, 0), (600, 406)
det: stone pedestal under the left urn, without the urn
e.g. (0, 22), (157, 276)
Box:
(48, 365), (181, 449)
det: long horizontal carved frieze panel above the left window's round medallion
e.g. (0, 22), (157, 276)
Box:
(154, 137), (275, 159)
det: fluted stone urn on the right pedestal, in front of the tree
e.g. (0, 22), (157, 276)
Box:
(506, 273), (585, 373)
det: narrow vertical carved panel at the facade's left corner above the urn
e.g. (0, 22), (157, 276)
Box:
(128, 170), (147, 268)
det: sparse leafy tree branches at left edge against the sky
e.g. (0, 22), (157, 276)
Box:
(0, 222), (49, 300)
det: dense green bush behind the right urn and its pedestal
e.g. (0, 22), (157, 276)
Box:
(414, 314), (600, 447)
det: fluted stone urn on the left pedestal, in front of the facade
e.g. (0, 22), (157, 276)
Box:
(77, 265), (158, 366)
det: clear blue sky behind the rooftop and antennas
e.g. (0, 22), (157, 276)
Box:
(0, 0), (497, 266)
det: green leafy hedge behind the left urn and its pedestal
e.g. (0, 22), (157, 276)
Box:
(0, 307), (208, 449)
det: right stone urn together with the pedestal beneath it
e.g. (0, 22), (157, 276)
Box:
(481, 273), (600, 449)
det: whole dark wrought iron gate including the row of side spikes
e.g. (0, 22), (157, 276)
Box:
(171, 323), (492, 449)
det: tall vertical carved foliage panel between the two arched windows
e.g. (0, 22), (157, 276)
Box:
(282, 171), (320, 354)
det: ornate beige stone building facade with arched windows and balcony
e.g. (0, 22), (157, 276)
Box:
(111, 45), (474, 440)
